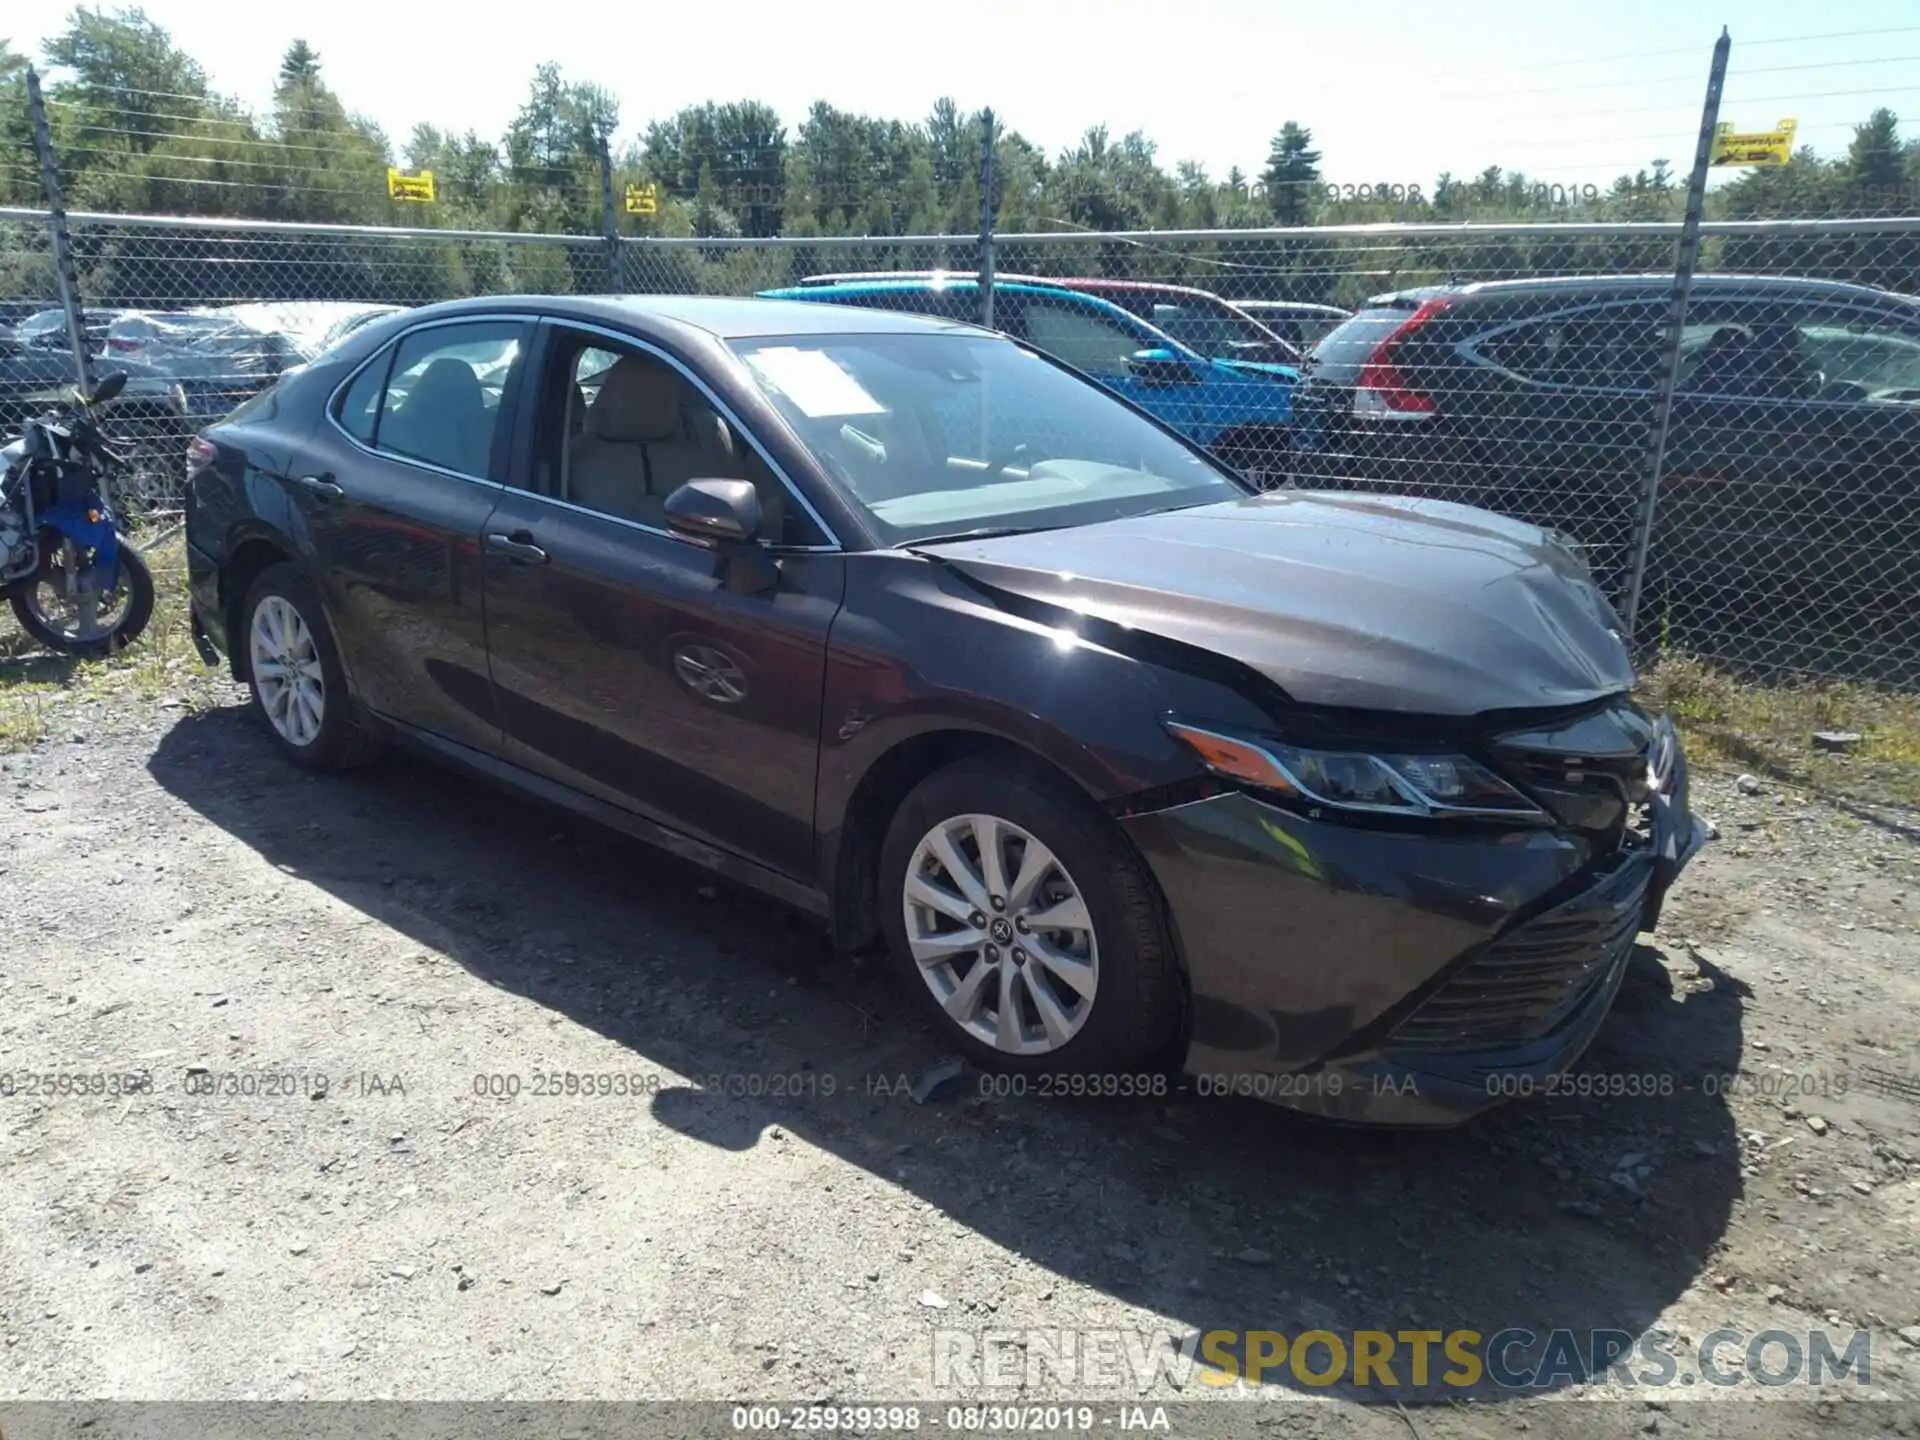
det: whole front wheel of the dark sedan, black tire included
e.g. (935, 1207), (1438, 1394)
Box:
(879, 756), (1181, 1075)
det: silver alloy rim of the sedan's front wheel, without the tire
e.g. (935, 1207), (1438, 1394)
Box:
(900, 814), (1100, 1056)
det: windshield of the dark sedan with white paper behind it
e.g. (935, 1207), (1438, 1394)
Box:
(735, 334), (1244, 543)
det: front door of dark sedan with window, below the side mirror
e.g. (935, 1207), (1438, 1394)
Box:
(484, 324), (843, 877)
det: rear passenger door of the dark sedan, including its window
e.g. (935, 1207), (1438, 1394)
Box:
(290, 317), (532, 749)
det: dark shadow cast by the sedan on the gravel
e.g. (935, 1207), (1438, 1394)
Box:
(150, 708), (1745, 1402)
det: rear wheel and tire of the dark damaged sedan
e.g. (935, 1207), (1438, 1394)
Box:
(234, 563), (386, 770)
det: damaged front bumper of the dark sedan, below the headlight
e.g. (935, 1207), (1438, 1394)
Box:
(1123, 725), (1705, 1125)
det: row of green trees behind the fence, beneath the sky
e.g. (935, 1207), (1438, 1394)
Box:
(11, 6), (1920, 301)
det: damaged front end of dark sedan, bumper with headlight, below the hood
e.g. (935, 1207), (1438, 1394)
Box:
(1121, 695), (1705, 1125)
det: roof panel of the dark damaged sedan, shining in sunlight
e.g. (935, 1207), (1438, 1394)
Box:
(372, 296), (973, 340)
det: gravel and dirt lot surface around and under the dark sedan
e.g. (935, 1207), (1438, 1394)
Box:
(0, 664), (1920, 1438)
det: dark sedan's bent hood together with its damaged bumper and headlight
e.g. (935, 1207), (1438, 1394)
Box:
(925, 493), (1703, 1125)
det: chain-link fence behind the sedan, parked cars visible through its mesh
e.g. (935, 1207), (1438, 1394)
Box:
(0, 209), (1920, 687)
